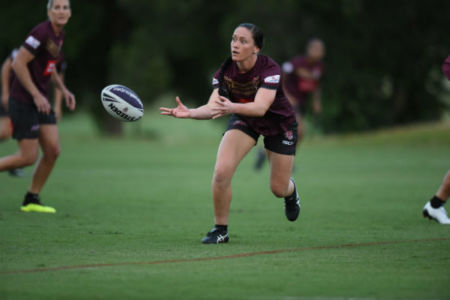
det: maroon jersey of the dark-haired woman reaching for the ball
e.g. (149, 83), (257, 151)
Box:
(213, 55), (295, 136)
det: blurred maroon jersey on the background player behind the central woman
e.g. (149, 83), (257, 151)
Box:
(283, 56), (323, 102)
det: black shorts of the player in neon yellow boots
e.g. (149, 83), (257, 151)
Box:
(9, 99), (56, 141)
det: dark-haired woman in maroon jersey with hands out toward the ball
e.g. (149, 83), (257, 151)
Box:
(161, 23), (300, 244)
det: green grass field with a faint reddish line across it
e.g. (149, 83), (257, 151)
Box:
(0, 115), (450, 300)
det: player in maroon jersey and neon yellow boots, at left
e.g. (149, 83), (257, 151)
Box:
(0, 0), (75, 213)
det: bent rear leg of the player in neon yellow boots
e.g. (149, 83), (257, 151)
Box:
(0, 139), (39, 172)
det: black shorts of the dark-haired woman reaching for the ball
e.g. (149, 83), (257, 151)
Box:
(226, 114), (298, 155)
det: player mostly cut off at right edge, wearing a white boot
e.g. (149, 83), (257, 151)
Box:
(422, 56), (450, 224)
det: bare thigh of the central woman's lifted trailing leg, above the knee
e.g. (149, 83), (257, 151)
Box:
(267, 150), (295, 186)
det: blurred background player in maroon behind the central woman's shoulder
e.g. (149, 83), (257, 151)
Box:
(255, 38), (325, 170)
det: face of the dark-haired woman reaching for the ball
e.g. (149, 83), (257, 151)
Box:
(231, 27), (259, 61)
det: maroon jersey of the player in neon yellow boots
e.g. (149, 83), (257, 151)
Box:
(11, 21), (64, 103)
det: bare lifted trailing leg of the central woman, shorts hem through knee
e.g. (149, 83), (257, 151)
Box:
(267, 150), (295, 198)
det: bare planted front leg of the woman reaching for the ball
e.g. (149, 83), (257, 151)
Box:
(212, 129), (255, 225)
